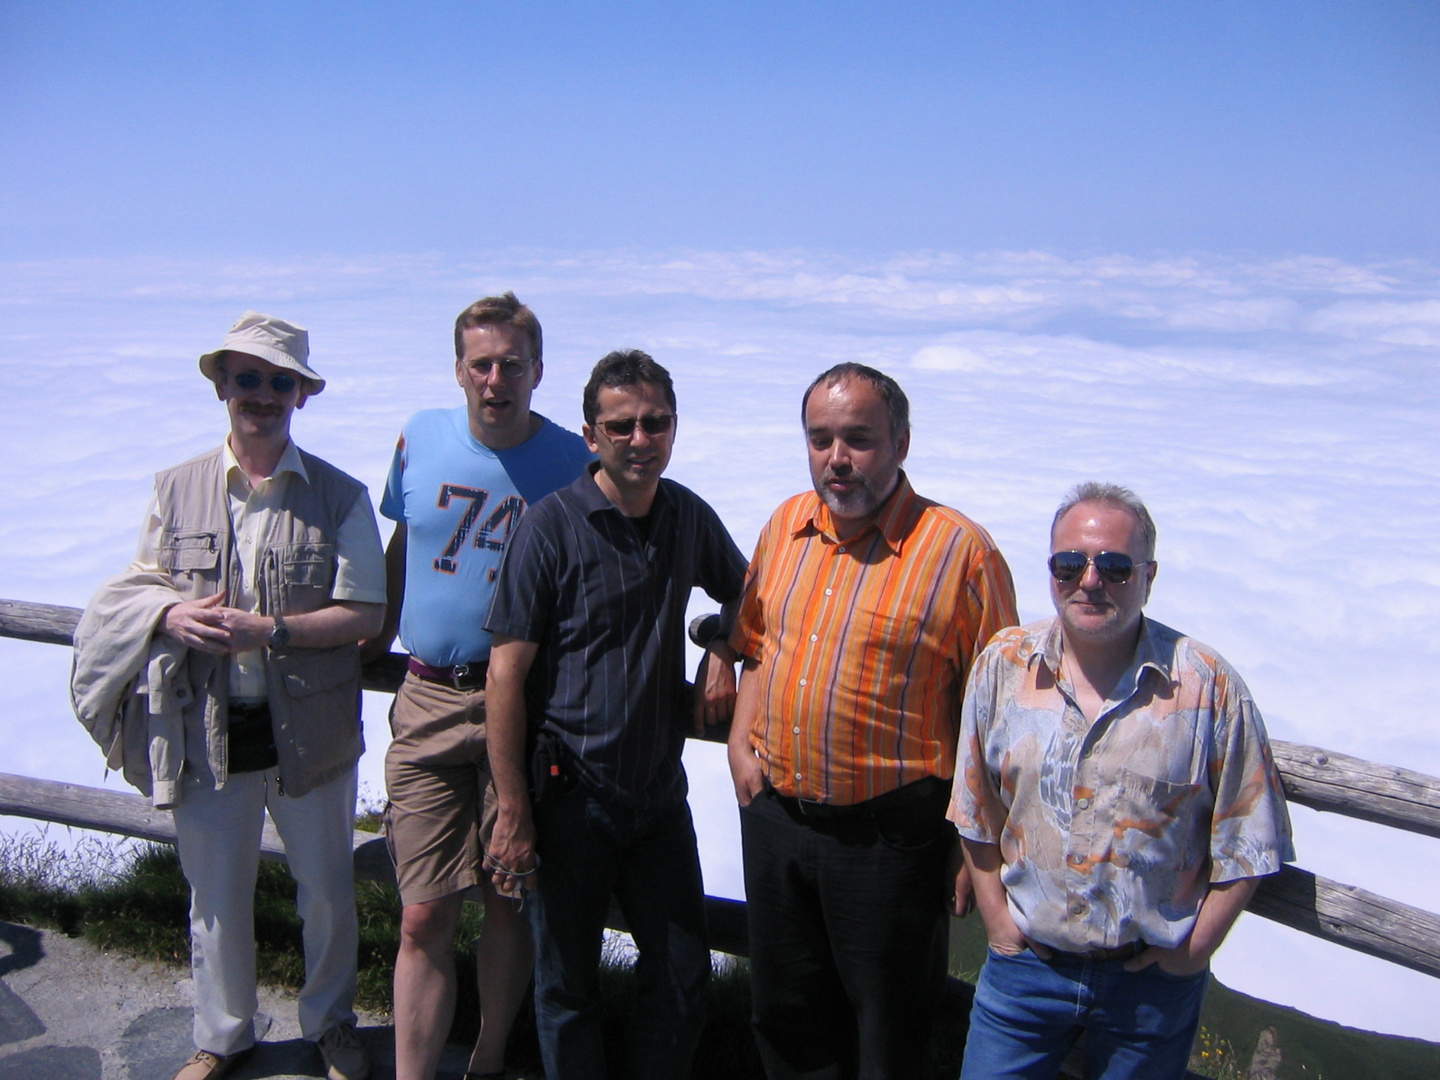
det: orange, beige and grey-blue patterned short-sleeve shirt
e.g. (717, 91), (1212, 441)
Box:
(949, 619), (1295, 952)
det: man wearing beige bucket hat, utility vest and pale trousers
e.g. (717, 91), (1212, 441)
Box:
(86, 311), (384, 1080)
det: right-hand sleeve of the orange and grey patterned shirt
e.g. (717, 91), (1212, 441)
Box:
(1210, 665), (1295, 881)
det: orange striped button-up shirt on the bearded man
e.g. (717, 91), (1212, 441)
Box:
(730, 472), (1018, 806)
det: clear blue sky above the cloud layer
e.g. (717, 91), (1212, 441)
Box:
(0, 0), (1440, 259)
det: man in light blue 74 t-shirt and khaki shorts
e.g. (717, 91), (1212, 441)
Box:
(366, 292), (590, 1080)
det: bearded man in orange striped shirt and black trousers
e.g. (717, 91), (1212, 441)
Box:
(730, 364), (1018, 1080)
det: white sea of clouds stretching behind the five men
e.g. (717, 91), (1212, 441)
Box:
(0, 251), (1440, 1040)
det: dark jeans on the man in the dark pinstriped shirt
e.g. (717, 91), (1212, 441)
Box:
(528, 788), (710, 1080)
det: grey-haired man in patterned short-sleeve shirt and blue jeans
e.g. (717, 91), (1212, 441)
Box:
(949, 482), (1295, 1080)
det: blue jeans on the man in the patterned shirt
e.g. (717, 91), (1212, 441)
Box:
(960, 949), (1210, 1080)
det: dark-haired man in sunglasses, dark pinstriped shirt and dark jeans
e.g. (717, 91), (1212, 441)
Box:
(485, 350), (744, 1080)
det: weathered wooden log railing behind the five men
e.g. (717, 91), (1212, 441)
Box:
(0, 599), (1440, 978)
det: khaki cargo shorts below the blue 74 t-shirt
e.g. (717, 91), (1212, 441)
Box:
(384, 672), (500, 904)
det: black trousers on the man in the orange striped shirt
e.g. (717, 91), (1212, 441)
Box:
(740, 778), (956, 1080)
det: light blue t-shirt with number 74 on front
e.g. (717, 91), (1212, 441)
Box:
(380, 406), (592, 667)
